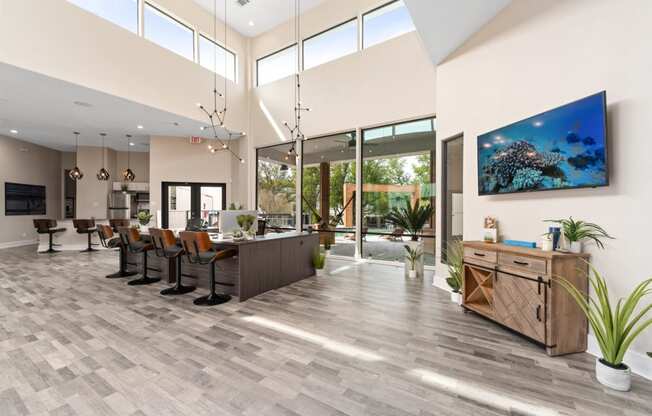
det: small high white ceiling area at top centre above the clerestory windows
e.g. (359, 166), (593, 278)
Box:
(193, 0), (326, 37)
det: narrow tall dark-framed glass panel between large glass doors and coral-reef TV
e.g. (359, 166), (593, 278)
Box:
(441, 136), (464, 263)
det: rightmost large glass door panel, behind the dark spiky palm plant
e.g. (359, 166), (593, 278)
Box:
(361, 118), (436, 266)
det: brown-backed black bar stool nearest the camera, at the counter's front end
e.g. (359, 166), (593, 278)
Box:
(179, 231), (237, 306)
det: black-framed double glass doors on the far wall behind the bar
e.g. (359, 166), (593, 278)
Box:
(161, 182), (226, 229)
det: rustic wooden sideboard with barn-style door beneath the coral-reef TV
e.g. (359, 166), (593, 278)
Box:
(462, 241), (588, 355)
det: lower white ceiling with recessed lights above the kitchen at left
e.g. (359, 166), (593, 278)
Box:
(0, 63), (234, 151)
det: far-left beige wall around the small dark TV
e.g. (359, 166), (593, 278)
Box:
(0, 136), (62, 247)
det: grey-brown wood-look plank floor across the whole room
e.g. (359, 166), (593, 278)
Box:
(0, 247), (652, 416)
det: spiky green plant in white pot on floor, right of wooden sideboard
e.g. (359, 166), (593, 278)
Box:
(555, 264), (652, 391)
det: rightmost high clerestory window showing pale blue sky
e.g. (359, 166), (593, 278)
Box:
(362, 0), (415, 48)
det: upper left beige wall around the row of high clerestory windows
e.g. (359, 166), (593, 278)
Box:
(0, 0), (247, 130)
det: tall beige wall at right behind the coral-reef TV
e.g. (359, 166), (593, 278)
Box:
(437, 0), (652, 360)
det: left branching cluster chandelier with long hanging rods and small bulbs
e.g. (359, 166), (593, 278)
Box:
(197, 0), (245, 163)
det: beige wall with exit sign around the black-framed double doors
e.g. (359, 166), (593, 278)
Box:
(149, 136), (246, 221)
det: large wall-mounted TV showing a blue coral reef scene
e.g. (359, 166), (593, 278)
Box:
(478, 91), (609, 195)
